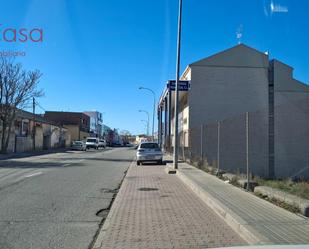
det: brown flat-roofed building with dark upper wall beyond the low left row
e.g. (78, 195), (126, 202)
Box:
(44, 111), (90, 141)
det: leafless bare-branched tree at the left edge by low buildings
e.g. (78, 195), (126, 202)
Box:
(0, 57), (43, 153)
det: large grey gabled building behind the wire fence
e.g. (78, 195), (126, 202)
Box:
(158, 44), (309, 178)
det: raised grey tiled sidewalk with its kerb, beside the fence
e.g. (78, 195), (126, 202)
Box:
(177, 160), (309, 244)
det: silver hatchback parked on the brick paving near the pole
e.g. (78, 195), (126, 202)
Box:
(136, 142), (163, 165)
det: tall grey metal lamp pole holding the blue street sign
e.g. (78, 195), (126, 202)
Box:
(173, 0), (182, 169)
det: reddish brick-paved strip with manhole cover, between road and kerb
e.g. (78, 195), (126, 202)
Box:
(94, 165), (246, 249)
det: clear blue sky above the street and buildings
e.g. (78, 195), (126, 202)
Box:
(0, 0), (309, 133)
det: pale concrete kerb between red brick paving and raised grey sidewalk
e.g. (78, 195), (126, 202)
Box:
(176, 163), (272, 245)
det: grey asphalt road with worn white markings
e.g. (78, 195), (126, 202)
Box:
(0, 148), (135, 249)
